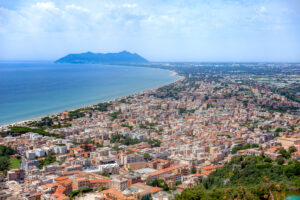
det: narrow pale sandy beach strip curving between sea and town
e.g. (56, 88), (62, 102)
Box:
(0, 68), (184, 130)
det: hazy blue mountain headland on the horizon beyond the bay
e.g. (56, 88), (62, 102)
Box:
(55, 51), (148, 63)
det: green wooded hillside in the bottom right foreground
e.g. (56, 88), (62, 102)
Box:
(175, 156), (300, 200)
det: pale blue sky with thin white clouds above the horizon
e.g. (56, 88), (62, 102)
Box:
(0, 0), (300, 62)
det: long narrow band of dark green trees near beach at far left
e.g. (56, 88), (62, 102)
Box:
(8, 126), (64, 138)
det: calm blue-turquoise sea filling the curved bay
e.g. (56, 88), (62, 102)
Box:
(0, 62), (178, 124)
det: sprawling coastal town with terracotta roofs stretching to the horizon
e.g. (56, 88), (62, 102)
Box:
(0, 64), (300, 200)
